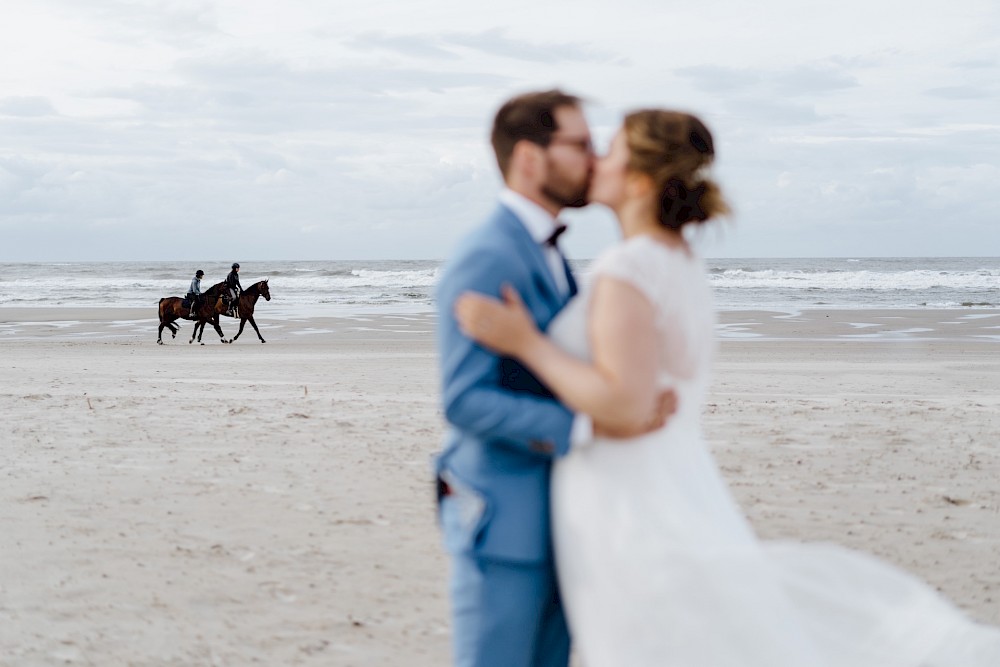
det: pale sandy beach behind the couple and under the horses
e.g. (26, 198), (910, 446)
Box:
(0, 306), (1000, 667)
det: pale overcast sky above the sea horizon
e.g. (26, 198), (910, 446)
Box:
(0, 0), (1000, 261)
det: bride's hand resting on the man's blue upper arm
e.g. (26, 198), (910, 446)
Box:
(455, 285), (542, 356)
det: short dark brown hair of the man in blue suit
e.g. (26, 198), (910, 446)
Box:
(490, 89), (580, 178)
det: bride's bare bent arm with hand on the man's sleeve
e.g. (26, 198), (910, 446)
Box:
(455, 276), (662, 432)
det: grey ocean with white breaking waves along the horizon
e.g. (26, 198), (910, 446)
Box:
(0, 257), (1000, 316)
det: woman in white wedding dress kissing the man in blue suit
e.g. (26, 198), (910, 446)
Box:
(456, 110), (1000, 667)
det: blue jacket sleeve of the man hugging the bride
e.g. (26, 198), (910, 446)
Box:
(437, 245), (573, 456)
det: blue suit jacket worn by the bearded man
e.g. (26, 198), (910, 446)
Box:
(436, 206), (576, 563)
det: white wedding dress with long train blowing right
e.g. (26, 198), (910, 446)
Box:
(549, 237), (1000, 667)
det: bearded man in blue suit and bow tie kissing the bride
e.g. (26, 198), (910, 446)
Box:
(436, 90), (672, 667)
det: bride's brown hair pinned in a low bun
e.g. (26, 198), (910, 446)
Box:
(625, 109), (729, 230)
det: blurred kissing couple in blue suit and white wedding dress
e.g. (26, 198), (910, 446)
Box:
(435, 90), (1000, 667)
